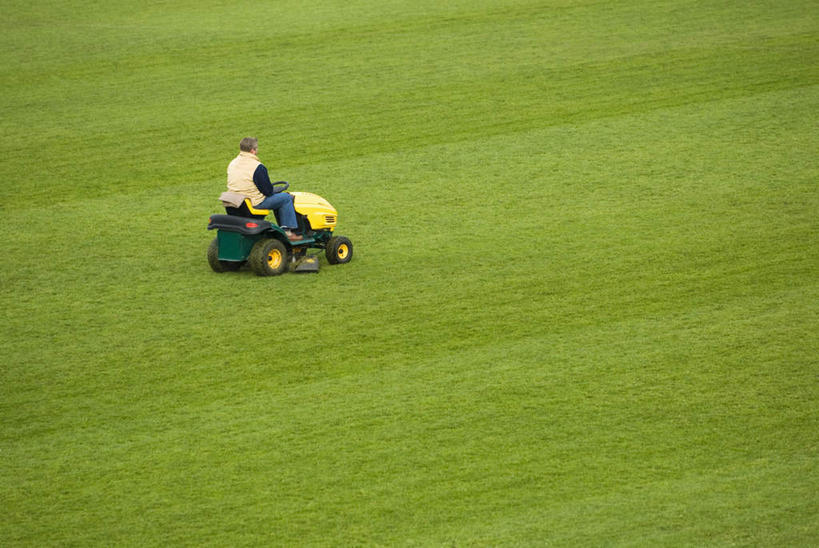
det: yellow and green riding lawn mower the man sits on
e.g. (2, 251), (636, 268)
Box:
(208, 182), (353, 276)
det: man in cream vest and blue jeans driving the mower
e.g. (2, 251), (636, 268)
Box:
(227, 137), (301, 241)
